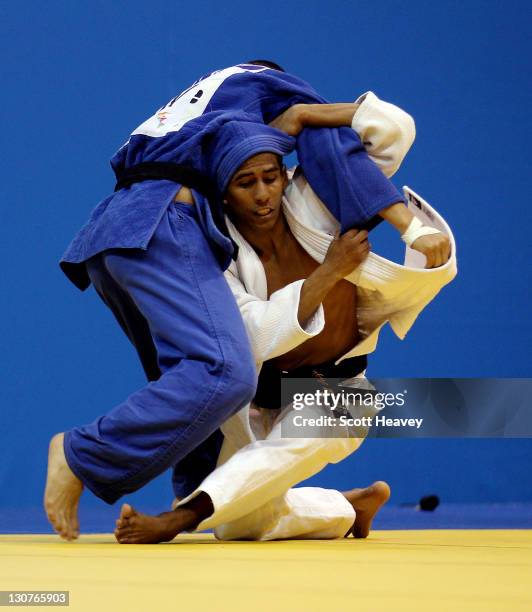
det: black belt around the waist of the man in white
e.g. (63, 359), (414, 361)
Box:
(253, 355), (368, 410)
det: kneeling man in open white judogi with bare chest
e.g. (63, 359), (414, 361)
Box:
(115, 95), (456, 543)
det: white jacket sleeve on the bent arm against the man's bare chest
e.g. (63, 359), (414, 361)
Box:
(225, 270), (325, 364)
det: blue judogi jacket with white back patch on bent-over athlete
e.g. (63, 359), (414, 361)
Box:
(60, 64), (403, 290)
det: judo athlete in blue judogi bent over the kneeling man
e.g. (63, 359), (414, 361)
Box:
(45, 65), (412, 539)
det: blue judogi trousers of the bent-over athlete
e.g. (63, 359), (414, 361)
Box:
(64, 203), (256, 503)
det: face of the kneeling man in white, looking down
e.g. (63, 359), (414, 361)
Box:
(224, 153), (288, 231)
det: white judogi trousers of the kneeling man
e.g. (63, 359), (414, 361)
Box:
(178, 402), (363, 540)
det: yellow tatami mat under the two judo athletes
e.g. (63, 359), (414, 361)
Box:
(0, 530), (532, 612)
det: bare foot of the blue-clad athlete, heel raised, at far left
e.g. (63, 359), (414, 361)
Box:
(44, 433), (83, 540)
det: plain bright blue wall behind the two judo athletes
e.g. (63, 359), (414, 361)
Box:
(0, 0), (532, 530)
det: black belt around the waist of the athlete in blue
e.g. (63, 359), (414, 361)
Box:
(115, 162), (238, 259)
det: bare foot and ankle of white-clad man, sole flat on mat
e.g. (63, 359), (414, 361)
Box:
(115, 493), (214, 544)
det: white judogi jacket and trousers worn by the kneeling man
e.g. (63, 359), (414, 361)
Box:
(179, 94), (456, 540)
